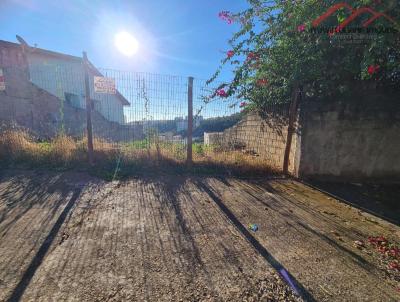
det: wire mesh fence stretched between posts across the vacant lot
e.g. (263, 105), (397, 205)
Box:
(0, 60), (296, 174)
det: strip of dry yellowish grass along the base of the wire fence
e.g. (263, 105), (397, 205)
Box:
(0, 130), (277, 178)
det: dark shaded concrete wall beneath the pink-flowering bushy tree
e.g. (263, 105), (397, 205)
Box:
(298, 96), (400, 182)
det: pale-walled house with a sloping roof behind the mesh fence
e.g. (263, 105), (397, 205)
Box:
(16, 39), (130, 124)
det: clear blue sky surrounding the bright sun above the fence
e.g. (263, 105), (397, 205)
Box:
(0, 0), (247, 80)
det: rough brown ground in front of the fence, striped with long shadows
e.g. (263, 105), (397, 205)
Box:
(0, 170), (400, 301)
